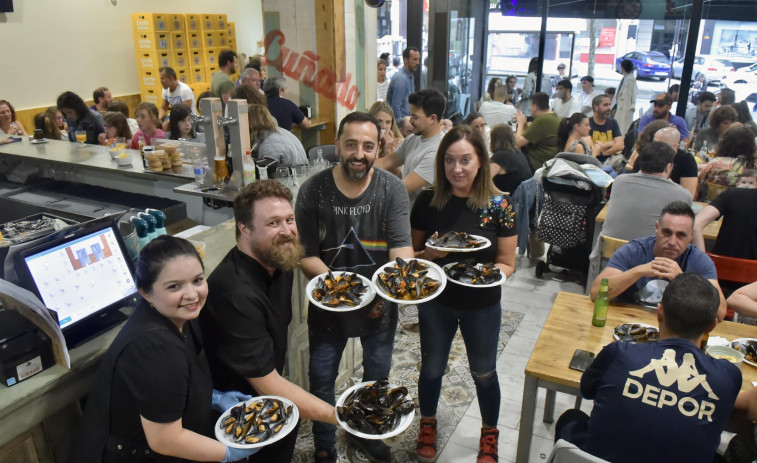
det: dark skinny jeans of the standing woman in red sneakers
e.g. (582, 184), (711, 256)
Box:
(418, 301), (502, 426)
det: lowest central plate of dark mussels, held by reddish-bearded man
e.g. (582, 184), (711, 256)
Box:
(334, 379), (415, 439)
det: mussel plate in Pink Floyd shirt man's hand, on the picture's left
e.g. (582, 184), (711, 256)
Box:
(305, 272), (376, 312)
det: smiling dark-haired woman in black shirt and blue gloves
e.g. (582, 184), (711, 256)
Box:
(72, 235), (254, 463)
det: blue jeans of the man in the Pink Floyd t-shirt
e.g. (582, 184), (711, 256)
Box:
(308, 328), (395, 450)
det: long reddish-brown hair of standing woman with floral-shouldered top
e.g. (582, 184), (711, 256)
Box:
(431, 125), (502, 210)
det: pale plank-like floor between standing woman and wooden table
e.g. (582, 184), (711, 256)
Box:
(437, 257), (592, 463)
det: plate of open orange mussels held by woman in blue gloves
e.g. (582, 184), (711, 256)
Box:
(215, 395), (300, 449)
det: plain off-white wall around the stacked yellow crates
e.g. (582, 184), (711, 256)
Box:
(0, 0), (263, 109)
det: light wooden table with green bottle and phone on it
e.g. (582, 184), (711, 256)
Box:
(515, 292), (757, 463)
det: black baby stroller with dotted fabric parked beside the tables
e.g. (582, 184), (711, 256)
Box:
(536, 153), (605, 278)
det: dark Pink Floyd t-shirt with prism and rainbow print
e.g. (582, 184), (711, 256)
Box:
(294, 167), (412, 337)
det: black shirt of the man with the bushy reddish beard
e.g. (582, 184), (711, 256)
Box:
(200, 246), (294, 395)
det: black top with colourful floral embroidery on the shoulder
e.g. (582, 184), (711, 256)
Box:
(410, 189), (518, 309)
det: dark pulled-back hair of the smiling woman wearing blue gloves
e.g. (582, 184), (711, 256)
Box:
(134, 235), (205, 294)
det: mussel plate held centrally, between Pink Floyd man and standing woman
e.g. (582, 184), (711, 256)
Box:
(371, 257), (447, 304)
